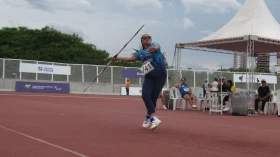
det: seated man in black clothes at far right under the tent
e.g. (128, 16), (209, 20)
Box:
(255, 80), (270, 114)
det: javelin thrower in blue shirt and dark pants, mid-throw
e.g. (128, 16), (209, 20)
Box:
(114, 34), (167, 130)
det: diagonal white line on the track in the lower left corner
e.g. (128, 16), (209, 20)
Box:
(0, 125), (89, 157)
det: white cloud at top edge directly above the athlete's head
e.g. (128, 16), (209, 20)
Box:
(120, 0), (163, 11)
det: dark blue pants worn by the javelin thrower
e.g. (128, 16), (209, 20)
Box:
(142, 74), (167, 115)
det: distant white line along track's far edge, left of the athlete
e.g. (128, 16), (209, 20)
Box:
(0, 94), (142, 101)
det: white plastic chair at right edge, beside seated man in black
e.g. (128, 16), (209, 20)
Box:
(264, 90), (280, 114)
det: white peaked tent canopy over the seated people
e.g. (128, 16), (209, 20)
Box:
(176, 0), (280, 53)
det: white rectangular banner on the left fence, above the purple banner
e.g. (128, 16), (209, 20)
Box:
(19, 63), (71, 75)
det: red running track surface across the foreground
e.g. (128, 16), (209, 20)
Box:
(0, 92), (280, 157)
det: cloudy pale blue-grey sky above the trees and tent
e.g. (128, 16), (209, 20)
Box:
(0, 0), (280, 70)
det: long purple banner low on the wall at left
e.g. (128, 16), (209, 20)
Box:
(16, 81), (70, 93)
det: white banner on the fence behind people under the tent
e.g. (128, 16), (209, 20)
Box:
(233, 74), (277, 84)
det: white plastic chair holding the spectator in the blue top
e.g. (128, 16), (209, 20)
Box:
(168, 87), (186, 110)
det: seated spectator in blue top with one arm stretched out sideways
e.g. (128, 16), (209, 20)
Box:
(170, 77), (197, 109)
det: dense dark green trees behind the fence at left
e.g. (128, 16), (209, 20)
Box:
(0, 26), (109, 65)
